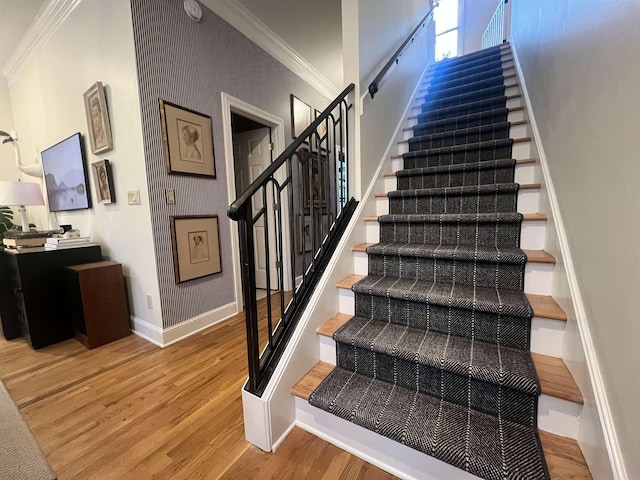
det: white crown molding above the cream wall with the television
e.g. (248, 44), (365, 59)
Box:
(0, 0), (82, 85)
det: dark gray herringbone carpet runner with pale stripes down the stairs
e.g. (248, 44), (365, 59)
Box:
(309, 47), (549, 479)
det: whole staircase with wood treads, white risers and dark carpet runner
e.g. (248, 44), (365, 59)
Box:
(293, 45), (590, 479)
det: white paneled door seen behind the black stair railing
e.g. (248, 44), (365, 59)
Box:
(233, 127), (278, 290)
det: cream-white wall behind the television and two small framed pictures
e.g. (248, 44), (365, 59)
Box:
(9, 0), (162, 326)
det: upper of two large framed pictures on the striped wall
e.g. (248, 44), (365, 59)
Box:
(160, 100), (216, 178)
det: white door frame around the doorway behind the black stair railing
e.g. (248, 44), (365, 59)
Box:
(220, 92), (291, 313)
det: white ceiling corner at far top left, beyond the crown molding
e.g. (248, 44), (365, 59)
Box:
(0, 0), (49, 69)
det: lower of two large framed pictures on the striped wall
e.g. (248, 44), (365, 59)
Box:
(170, 215), (222, 283)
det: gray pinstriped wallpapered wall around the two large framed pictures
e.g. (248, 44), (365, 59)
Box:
(131, 0), (329, 328)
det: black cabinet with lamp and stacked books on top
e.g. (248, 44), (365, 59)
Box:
(0, 245), (102, 348)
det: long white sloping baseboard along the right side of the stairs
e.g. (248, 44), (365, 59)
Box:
(511, 42), (628, 480)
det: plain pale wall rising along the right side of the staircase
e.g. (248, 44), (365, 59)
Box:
(511, 0), (640, 479)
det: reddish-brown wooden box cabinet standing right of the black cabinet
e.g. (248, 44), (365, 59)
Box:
(66, 260), (131, 348)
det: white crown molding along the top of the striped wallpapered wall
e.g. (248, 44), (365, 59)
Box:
(201, 0), (341, 98)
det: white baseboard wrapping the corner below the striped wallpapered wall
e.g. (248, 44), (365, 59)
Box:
(131, 302), (238, 347)
